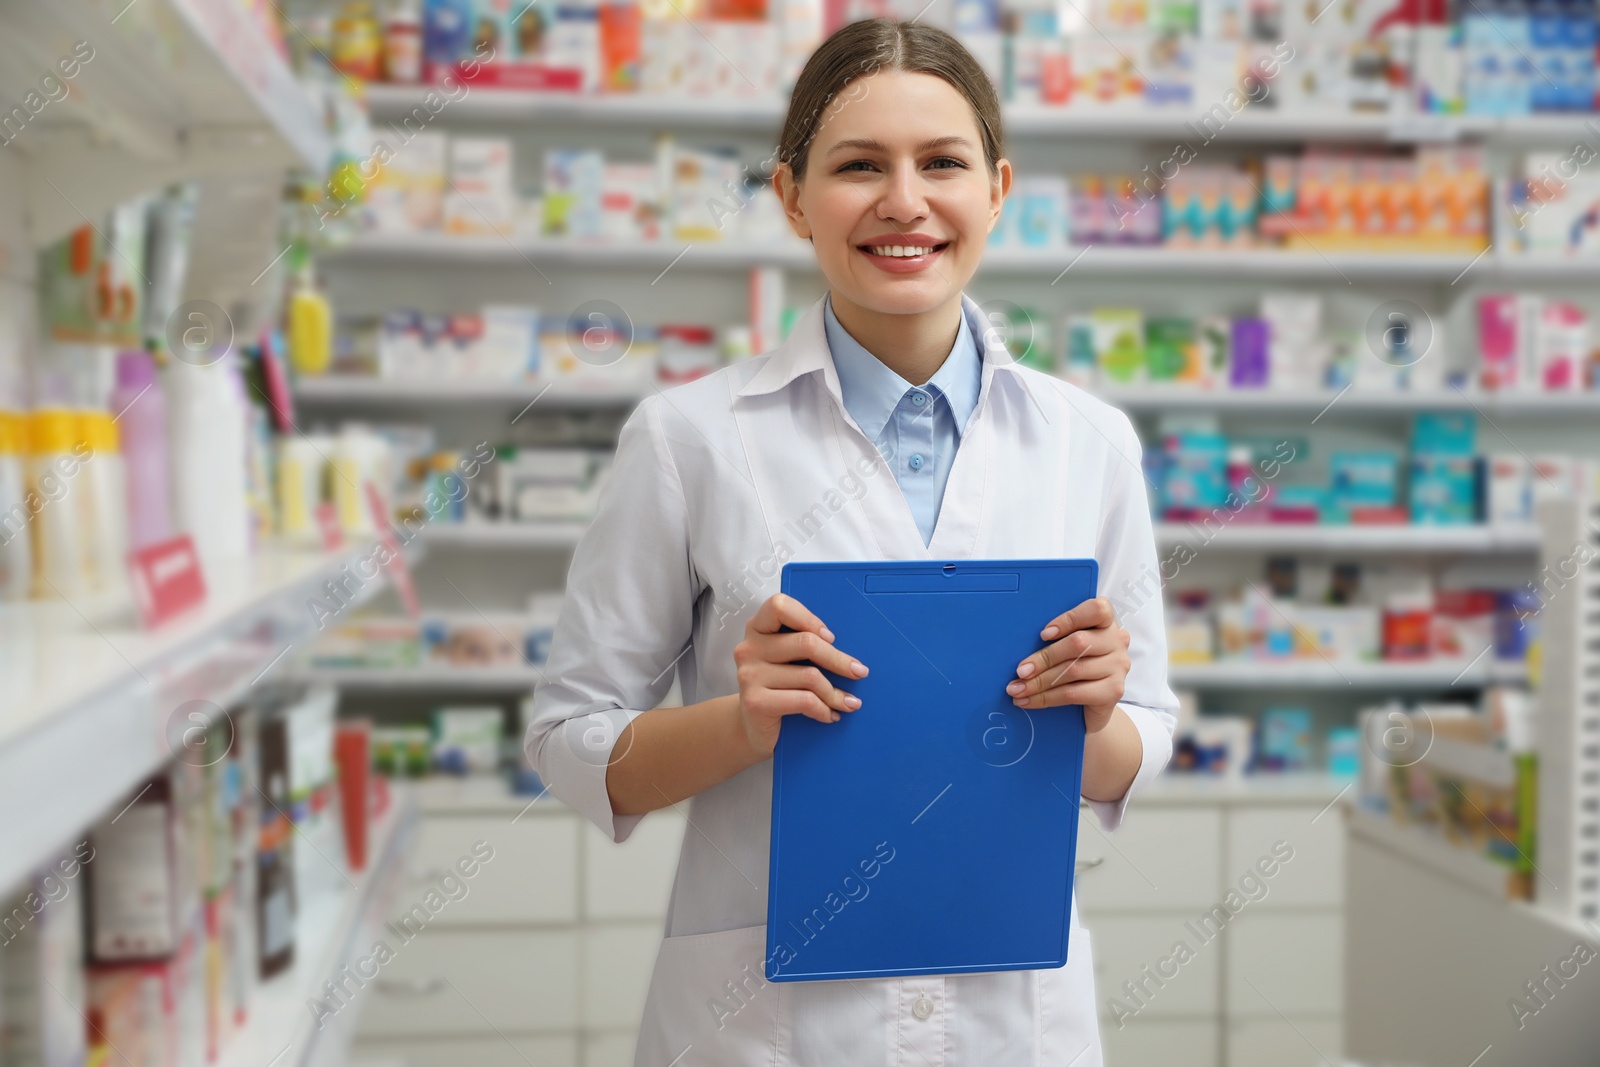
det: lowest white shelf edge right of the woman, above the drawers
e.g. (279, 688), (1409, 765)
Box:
(1166, 654), (1528, 689)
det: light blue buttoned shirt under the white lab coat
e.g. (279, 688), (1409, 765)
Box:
(822, 298), (984, 544)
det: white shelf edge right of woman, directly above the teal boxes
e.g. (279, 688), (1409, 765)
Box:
(1090, 384), (1600, 418)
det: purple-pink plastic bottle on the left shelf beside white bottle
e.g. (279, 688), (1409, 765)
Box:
(110, 352), (173, 550)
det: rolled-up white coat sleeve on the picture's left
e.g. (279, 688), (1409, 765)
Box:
(523, 397), (699, 841)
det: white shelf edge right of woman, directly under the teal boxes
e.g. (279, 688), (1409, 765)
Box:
(1155, 524), (1539, 553)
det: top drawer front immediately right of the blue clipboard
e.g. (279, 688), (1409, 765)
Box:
(1074, 800), (1222, 913)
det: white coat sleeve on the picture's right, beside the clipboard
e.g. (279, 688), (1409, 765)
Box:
(1088, 413), (1178, 830)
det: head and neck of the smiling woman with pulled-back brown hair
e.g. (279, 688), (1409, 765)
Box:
(773, 19), (1011, 382)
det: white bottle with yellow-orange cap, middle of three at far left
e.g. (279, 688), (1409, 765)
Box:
(27, 408), (90, 600)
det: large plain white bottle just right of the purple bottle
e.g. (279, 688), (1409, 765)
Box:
(163, 354), (250, 581)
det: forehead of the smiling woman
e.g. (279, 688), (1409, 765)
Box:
(816, 70), (982, 152)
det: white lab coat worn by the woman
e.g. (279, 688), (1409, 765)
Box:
(525, 292), (1176, 1067)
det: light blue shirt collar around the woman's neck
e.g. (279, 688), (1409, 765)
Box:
(822, 298), (982, 440)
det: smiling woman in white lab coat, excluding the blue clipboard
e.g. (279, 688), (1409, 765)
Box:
(525, 19), (1176, 1067)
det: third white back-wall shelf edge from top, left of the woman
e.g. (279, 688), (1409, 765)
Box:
(293, 374), (653, 410)
